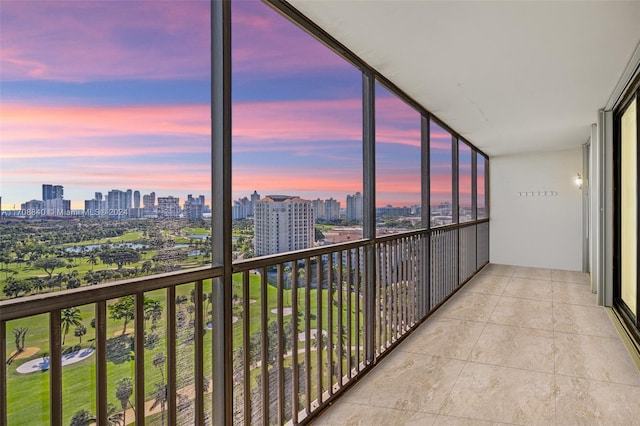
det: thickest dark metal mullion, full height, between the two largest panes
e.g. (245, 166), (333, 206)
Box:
(210, 1), (233, 425)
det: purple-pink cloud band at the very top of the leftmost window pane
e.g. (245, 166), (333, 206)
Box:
(0, 0), (210, 82)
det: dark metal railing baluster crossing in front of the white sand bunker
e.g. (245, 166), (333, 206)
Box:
(49, 309), (62, 426)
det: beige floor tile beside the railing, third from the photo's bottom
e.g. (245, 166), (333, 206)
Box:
(398, 316), (484, 360)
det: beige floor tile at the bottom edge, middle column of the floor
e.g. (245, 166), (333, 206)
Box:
(440, 362), (555, 424)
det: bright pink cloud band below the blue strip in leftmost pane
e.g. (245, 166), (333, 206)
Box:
(1, 103), (211, 159)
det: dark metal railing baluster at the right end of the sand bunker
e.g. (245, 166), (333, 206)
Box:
(95, 300), (109, 425)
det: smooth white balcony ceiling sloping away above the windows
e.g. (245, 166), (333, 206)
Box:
(289, 0), (640, 156)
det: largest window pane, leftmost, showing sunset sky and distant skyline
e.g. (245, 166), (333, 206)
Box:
(0, 1), (211, 297)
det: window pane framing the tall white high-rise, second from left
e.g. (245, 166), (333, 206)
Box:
(232, 1), (363, 259)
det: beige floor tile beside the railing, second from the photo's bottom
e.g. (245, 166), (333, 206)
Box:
(343, 351), (464, 414)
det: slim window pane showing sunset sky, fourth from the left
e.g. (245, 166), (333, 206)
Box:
(429, 120), (453, 226)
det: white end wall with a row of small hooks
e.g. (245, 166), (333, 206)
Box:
(490, 148), (582, 271)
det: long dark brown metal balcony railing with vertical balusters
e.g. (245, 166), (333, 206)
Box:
(0, 220), (489, 426)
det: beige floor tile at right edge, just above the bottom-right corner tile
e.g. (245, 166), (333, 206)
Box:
(554, 332), (640, 388)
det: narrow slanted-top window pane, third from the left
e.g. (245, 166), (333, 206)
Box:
(375, 84), (422, 234)
